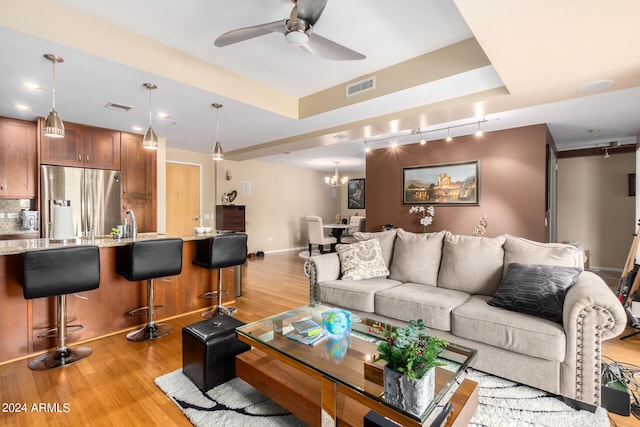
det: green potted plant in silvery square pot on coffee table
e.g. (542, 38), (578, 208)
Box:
(373, 319), (449, 415)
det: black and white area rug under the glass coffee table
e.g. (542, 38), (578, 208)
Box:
(155, 369), (609, 427)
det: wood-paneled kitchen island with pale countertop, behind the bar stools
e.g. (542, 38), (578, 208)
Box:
(0, 233), (242, 363)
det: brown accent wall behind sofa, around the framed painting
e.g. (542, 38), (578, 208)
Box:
(366, 124), (548, 241)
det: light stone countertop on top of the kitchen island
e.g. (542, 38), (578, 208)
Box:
(0, 233), (215, 256)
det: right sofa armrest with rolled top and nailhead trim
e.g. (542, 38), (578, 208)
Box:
(560, 271), (627, 406)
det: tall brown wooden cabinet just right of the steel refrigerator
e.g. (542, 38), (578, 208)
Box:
(120, 132), (157, 233)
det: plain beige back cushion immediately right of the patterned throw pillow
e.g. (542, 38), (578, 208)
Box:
(389, 229), (445, 286)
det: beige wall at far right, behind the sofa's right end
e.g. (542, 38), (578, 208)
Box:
(557, 151), (636, 270)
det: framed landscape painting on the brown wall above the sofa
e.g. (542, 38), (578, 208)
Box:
(402, 160), (480, 206)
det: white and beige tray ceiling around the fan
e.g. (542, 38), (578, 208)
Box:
(0, 0), (640, 171)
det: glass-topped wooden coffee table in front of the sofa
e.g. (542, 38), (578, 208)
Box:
(236, 304), (478, 426)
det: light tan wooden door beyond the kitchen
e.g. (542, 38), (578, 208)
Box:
(167, 163), (200, 234)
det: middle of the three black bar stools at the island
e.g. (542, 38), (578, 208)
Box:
(116, 239), (182, 341)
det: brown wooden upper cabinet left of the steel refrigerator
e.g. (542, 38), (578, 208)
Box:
(0, 117), (38, 199)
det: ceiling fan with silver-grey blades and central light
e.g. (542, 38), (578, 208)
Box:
(214, 0), (366, 61)
